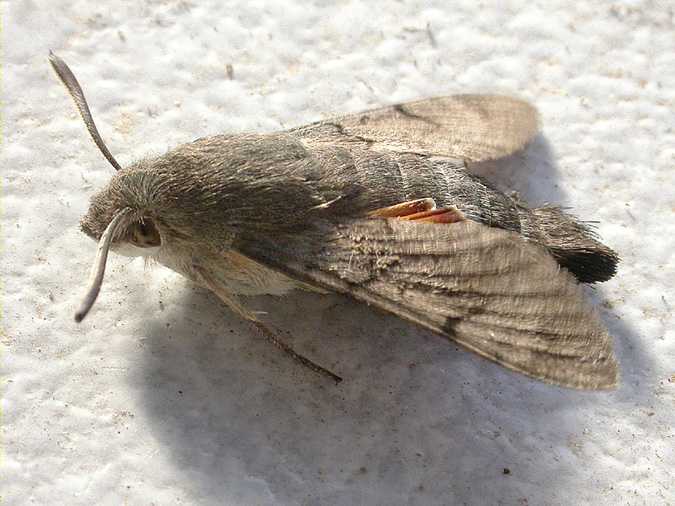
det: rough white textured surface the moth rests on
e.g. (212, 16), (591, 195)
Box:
(0, 0), (675, 505)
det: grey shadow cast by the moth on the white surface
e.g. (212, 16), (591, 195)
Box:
(130, 136), (645, 504)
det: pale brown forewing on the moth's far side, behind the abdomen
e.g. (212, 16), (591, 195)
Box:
(290, 95), (539, 161)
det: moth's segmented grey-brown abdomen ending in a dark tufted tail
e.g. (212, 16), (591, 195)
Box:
(312, 146), (618, 283)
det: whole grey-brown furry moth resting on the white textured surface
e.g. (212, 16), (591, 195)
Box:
(50, 52), (619, 389)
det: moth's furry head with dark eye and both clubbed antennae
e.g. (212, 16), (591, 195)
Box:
(49, 52), (169, 322)
